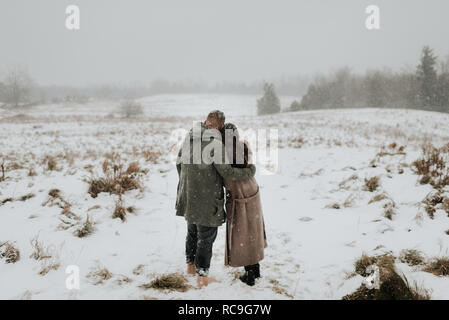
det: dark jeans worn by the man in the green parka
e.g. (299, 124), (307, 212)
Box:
(186, 223), (218, 276)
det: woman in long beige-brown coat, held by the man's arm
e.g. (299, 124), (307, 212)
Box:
(222, 123), (267, 286)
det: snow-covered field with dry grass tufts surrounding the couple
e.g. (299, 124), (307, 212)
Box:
(0, 95), (449, 299)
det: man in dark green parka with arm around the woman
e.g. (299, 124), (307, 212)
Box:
(176, 110), (256, 287)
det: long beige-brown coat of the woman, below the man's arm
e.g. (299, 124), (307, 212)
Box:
(224, 178), (267, 267)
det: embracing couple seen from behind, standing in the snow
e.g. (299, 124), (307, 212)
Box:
(176, 110), (267, 287)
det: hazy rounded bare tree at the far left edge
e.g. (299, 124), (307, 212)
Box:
(3, 66), (33, 107)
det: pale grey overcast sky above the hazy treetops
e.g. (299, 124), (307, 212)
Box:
(0, 0), (449, 85)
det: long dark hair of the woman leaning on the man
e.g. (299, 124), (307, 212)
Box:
(221, 123), (249, 168)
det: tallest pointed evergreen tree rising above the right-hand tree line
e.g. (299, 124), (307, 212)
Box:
(416, 46), (438, 108)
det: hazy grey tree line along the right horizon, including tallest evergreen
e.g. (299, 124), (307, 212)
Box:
(290, 46), (449, 112)
